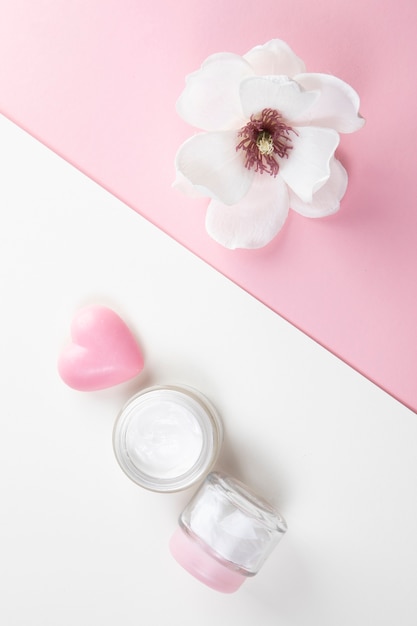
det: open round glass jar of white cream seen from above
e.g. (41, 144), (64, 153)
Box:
(113, 386), (223, 492)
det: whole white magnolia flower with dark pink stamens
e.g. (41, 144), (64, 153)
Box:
(176, 39), (364, 248)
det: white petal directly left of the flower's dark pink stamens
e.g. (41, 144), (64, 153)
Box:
(175, 131), (254, 204)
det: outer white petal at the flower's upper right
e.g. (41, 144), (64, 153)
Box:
(294, 74), (365, 133)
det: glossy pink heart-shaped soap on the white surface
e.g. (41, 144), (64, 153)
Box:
(58, 305), (143, 391)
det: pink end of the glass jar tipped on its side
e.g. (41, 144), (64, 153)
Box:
(169, 528), (246, 593)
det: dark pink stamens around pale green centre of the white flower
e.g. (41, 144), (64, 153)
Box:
(236, 109), (296, 176)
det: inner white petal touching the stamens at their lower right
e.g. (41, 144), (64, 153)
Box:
(278, 126), (339, 202)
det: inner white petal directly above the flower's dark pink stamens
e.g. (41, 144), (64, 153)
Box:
(240, 76), (318, 123)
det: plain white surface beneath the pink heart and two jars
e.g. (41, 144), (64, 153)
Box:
(0, 113), (417, 626)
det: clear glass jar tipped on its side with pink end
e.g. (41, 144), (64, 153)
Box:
(170, 472), (287, 593)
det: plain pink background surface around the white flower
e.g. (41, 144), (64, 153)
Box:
(0, 0), (417, 411)
